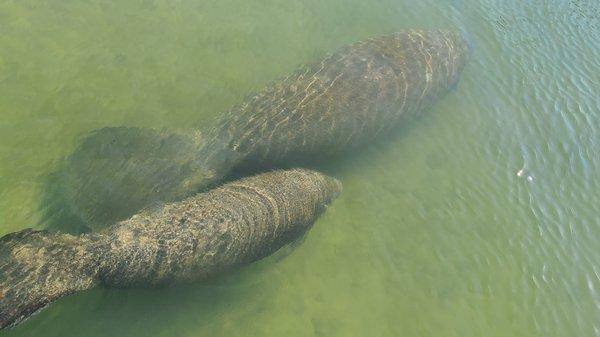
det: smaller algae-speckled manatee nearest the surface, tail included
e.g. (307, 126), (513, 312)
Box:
(0, 169), (341, 328)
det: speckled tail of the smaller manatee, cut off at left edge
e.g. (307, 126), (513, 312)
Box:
(0, 229), (98, 329)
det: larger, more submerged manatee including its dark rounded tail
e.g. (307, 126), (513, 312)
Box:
(49, 30), (467, 229)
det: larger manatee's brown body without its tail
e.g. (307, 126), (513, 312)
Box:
(207, 31), (467, 163)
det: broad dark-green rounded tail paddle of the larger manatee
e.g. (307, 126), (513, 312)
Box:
(44, 127), (215, 230)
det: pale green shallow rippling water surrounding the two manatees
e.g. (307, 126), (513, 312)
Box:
(0, 0), (600, 337)
